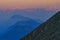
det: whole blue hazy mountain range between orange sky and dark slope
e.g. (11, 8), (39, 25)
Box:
(0, 9), (58, 40)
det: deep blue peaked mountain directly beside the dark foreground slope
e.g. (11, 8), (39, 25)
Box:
(0, 15), (42, 40)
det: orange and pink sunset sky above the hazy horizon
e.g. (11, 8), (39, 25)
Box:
(0, 0), (60, 10)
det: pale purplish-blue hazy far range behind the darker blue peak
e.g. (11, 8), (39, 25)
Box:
(0, 8), (57, 22)
